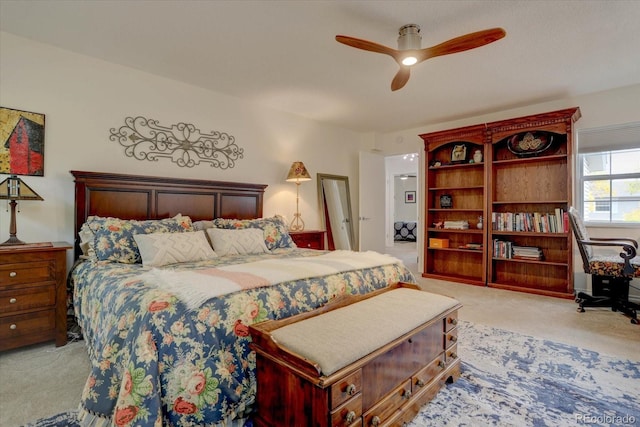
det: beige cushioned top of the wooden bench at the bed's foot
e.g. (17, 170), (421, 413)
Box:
(271, 288), (458, 375)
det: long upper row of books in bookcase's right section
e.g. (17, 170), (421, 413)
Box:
(491, 208), (569, 233)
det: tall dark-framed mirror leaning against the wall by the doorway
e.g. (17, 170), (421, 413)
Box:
(317, 173), (354, 250)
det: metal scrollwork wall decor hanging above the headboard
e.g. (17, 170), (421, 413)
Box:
(109, 116), (244, 169)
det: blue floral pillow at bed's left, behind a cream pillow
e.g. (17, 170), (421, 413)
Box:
(90, 215), (192, 264)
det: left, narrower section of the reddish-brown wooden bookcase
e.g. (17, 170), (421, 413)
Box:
(420, 125), (488, 285)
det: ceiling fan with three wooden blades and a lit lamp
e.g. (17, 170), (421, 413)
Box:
(336, 24), (507, 91)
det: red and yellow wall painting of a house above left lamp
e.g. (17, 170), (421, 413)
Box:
(0, 107), (44, 176)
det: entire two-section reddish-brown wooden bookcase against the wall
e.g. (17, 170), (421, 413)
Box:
(420, 108), (580, 298)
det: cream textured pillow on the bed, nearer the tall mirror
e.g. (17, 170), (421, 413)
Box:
(206, 228), (269, 256)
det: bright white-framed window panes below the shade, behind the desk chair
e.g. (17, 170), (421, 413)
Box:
(578, 148), (640, 225)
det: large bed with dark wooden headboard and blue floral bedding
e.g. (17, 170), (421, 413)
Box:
(69, 171), (415, 426)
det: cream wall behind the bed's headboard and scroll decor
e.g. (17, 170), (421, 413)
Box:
(0, 32), (370, 260)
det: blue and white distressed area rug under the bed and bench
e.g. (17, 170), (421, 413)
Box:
(22, 322), (640, 427)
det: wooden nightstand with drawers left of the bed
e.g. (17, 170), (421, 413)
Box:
(0, 242), (71, 351)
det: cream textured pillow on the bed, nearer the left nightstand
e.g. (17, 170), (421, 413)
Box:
(133, 231), (217, 267)
